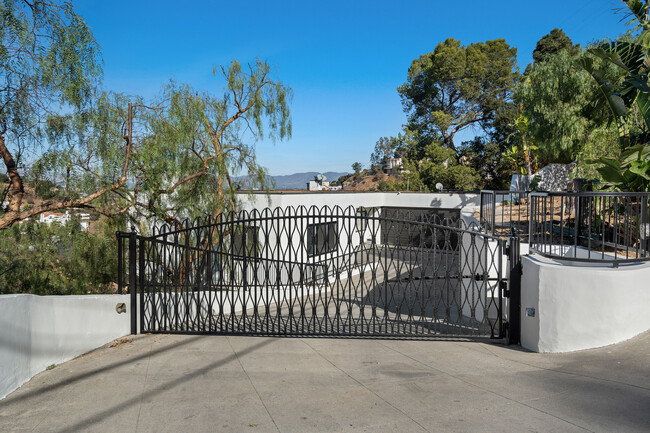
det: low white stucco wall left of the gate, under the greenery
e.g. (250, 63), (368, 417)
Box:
(0, 295), (131, 398)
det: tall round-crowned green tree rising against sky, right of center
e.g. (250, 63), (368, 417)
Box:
(398, 38), (518, 150)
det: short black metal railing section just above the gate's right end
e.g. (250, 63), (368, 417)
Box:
(479, 190), (530, 242)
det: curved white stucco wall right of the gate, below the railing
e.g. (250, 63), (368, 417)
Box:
(521, 255), (650, 352)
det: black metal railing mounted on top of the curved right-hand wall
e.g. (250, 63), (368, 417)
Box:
(529, 192), (650, 265)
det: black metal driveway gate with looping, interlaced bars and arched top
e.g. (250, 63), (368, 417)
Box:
(118, 207), (518, 339)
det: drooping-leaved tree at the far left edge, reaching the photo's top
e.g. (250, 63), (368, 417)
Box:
(0, 0), (101, 219)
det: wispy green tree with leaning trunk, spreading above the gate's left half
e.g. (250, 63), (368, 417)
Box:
(0, 61), (291, 228)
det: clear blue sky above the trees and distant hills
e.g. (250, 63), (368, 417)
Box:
(74, 0), (625, 175)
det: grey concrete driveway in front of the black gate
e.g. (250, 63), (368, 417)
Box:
(0, 332), (650, 433)
